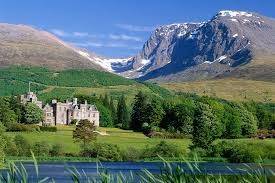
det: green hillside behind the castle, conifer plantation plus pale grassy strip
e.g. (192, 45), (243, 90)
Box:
(0, 66), (171, 102)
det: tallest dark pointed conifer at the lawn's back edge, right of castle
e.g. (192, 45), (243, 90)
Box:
(131, 91), (147, 131)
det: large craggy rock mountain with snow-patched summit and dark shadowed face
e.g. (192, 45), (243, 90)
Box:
(117, 10), (275, 81)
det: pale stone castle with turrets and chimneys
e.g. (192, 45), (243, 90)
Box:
(21, 89), (99, 126)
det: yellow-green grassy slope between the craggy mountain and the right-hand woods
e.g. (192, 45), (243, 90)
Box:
(161, 78), (275, 102)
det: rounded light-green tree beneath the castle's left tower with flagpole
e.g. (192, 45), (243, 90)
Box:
(24, 103), (44, 124)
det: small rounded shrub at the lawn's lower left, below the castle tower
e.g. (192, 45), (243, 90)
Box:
(14, 135), (31, 156)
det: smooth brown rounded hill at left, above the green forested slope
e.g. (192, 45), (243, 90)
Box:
(0, 23), (105, 70)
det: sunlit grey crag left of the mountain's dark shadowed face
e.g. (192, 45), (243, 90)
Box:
(119, 23), (200, 78)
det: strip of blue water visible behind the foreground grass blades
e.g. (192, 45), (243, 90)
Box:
(1, 162), (275, 183)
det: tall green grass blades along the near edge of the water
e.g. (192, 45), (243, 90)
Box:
(0, 156), (275, 183)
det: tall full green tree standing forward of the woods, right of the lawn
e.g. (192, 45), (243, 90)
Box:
(192, 103), (219, 149)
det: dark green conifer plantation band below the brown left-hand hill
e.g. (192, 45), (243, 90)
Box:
(0, 66), (136, 96)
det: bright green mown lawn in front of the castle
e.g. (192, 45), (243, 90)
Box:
(7, 126), (191, 153)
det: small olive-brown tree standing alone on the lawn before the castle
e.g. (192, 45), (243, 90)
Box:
(73, 119), (96, 147)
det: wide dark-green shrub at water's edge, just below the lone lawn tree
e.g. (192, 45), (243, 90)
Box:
(81, 143), (121, 161)
